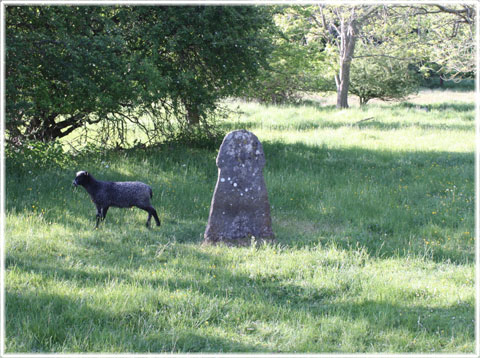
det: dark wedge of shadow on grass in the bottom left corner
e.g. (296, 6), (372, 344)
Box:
(5, 290), (263, 353)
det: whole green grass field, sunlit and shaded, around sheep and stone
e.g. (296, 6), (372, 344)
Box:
(5, 92), (475, 353)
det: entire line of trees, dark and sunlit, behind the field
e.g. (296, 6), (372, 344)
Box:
(5, 5), (475, 145)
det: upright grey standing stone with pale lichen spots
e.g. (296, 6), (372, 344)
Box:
(204, 130), (275, 245)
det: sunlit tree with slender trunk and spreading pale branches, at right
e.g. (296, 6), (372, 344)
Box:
(284, 5), (475, 108)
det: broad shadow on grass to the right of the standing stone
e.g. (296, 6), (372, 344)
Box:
(264, 142), (475, 263)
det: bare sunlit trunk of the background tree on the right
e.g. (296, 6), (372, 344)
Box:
(335, 19), (357, 109)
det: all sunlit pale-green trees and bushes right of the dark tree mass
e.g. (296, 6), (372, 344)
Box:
(249, 4), (475, 108)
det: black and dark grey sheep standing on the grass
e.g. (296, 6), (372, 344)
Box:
(72, 170), (160, 228)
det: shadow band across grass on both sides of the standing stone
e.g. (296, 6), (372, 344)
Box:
(6, 141), (475, 263)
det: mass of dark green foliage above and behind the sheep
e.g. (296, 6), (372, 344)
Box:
(6, 6), (269, 144)
